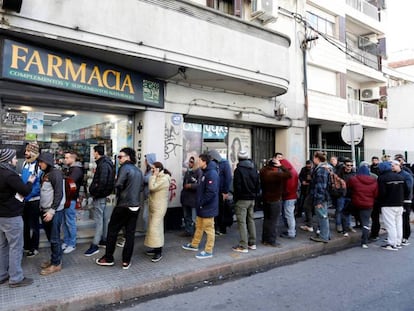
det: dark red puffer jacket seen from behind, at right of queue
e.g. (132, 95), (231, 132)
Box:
(347, 175), (378, 209)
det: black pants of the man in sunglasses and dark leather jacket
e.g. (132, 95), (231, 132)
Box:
(105, 206), (138, 263)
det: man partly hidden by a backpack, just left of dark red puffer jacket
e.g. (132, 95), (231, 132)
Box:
(335, 158), (356, 237)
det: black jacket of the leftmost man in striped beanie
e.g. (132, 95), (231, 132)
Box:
(0, 163), (32, 218)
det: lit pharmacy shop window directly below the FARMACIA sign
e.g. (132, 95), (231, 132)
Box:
(0, 105), (133, 167)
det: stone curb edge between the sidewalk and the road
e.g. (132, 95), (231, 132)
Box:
(29, 234), (360, 311)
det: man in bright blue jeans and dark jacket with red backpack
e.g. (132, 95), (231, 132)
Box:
(62, 151), (83, 254)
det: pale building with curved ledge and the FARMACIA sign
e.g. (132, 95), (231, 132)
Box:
(0, 0), (306, 229)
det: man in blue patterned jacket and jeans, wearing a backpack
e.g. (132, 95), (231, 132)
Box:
(310, 151), (331, 243)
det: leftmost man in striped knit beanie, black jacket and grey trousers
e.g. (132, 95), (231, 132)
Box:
(0, 149), (36, 287)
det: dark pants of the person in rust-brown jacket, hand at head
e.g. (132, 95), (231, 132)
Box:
(262, 201), (282, 244)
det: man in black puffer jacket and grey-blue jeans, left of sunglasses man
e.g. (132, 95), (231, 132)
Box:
(85, 145), (115, 256)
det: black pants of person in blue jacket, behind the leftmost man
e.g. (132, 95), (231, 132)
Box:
(23, 200), (40, 251)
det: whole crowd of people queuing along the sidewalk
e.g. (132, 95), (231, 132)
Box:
(0, 143), (413, 287)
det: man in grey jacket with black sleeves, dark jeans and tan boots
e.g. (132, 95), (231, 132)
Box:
(38, 152), (66, 275)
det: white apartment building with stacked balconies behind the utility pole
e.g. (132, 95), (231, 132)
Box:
(306, 0), (387, 160)
